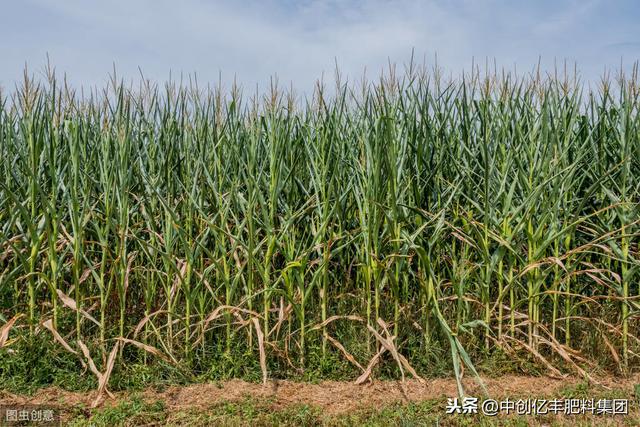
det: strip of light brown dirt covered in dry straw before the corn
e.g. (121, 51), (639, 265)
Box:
(0, 374), (640, 415)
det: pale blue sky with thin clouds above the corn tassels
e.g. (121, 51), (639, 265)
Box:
(0, 0), (640, 91)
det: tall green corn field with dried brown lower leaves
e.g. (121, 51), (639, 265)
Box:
(0, 65), (640, 396)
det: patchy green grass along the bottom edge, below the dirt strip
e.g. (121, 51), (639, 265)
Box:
(58, 385), (640, 427)
